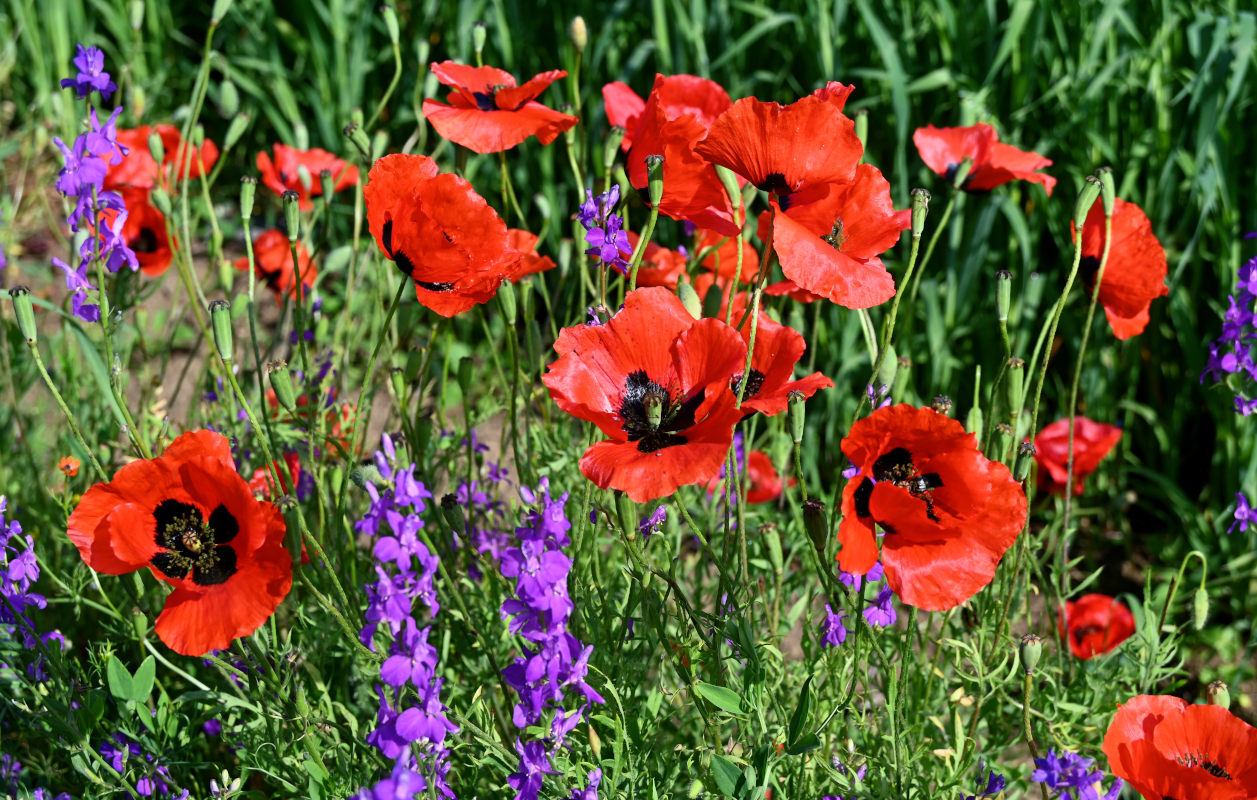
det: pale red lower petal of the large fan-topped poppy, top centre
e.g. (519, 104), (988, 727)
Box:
(773, 201), (895, 308)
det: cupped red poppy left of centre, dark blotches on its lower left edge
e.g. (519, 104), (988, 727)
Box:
(363, 153), (530, 317)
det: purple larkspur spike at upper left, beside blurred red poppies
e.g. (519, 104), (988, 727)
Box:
(53, 44), (140, 322)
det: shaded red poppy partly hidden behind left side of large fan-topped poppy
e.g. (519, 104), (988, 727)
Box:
(626, 75), (738, 236)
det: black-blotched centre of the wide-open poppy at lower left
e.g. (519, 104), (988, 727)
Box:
(150, 499), (240, 586)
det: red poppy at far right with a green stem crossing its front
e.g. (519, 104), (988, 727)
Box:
(1071, 199), (1170, 340)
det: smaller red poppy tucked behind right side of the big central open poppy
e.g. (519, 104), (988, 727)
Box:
(730, 308), (833, 416)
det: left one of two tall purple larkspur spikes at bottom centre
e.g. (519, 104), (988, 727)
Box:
(353, 435), (459, 800)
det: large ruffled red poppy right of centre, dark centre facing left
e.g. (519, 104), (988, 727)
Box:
(838, 404), (1026, 611)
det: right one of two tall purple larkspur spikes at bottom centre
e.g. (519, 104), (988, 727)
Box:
(500, 478), (605, 800)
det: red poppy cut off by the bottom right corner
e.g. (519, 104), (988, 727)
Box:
(1104, 694), (1257, 800)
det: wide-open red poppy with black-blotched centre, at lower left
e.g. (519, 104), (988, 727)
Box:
(68, 430), (293, 655)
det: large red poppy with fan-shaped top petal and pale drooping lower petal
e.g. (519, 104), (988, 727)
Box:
(698, 94), (909, 308)
